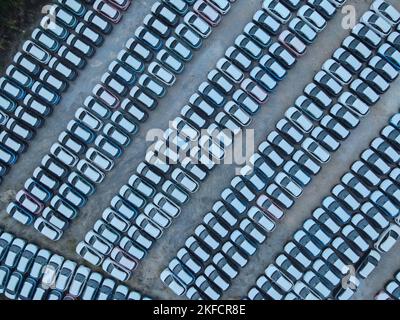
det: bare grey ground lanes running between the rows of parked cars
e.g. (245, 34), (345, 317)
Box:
(0, 0), (400, 300)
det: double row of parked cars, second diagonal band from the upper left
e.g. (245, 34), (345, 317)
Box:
(7, 0), (234, 241)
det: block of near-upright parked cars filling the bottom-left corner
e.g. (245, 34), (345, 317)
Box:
(0, 230), (150, 300)
